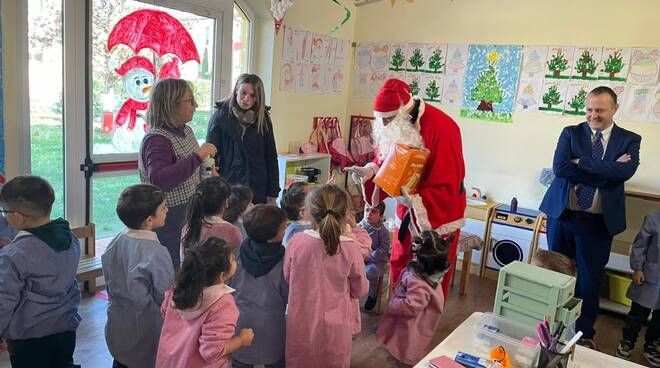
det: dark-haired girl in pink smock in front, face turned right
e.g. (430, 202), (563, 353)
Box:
(156, 237), (254, 368)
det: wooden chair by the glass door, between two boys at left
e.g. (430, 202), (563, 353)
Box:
(71, 223), (103, 295)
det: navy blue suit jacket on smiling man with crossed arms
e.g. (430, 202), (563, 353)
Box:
(539, 122), (642, 235)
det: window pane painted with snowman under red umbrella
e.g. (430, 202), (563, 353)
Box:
(91, 0), (216, 155)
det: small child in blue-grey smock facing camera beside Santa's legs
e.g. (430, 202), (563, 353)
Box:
(358, 202), (390, 312)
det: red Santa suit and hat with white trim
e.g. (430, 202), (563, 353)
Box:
(363, 79), (466, 300)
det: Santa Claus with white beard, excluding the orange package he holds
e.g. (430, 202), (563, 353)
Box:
(346, 79), (466, 300)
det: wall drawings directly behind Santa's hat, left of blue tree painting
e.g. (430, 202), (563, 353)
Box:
(353, 42), (452, 102)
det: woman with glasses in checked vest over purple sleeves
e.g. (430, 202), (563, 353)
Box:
(138, 79), (217, 269)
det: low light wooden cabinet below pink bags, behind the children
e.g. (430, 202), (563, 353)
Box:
(277, 153), (330, 204)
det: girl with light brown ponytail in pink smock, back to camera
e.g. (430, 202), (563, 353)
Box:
(284, 184), (369, 368)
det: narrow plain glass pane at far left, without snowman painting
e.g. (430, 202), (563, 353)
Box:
(28, 0), (64, 218)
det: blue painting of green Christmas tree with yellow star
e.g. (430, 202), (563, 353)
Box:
(461, 45), (522, 123)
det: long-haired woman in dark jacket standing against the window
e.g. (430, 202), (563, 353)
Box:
(206, 74), (280, 204)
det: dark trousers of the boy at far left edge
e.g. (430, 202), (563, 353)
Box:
(9, 331), (76, 368)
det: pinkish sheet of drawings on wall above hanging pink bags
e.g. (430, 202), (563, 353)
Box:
(280, 27), (348, 95)
